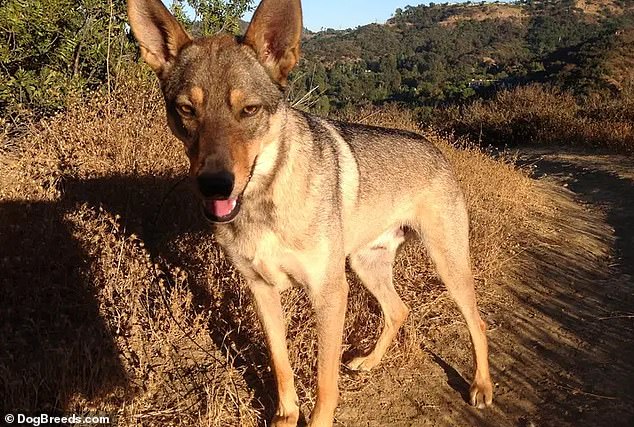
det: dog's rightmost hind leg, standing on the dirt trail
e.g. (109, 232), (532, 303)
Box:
(419, 192), (493, 408)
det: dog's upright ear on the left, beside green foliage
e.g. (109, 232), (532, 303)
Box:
(128, 0), (191, 77)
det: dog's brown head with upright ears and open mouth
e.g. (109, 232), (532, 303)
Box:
(128, 0), (302, 223)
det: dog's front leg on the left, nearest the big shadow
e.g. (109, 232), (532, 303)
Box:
(249, 281), (299, 427)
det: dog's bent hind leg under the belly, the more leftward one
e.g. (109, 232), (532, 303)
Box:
(347, 228), (409, 370)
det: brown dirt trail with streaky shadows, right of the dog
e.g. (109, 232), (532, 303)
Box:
(337, 148), (634, 427)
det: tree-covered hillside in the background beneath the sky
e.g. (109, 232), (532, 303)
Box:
(295, 0), (634, 112)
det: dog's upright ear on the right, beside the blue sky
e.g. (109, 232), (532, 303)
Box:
(244, 0), (302, 86)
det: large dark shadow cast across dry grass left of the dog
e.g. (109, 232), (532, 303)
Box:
(0, 176), (282, 420)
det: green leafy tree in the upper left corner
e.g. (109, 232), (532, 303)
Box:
(0, 0), (129, 121)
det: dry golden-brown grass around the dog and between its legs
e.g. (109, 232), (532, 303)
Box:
(0, 69), (604, 426)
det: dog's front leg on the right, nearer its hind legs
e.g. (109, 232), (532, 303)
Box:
(308, 271), (348, 427)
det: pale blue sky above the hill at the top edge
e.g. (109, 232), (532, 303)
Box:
(243, 0), (482, 31)
